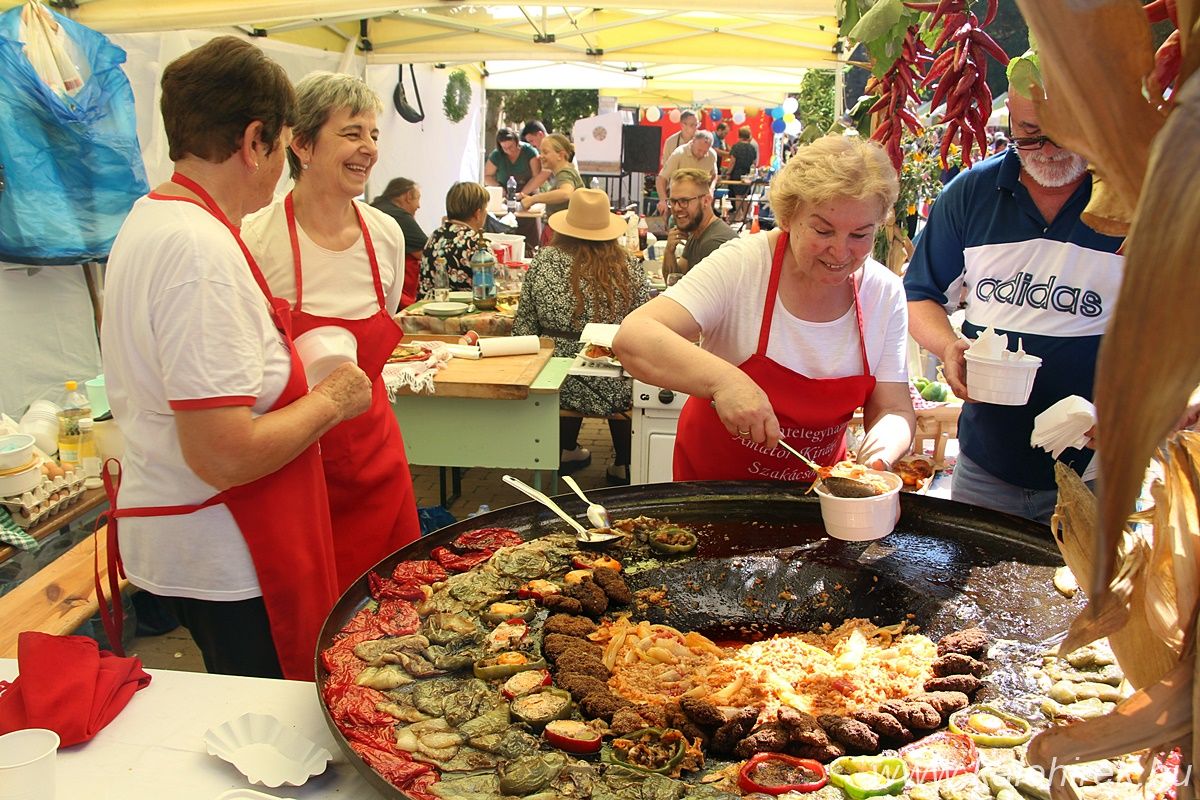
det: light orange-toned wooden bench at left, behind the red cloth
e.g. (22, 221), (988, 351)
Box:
(0, 520), (128, 658)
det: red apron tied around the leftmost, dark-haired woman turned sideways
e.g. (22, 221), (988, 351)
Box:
(96, 173), (337, 680)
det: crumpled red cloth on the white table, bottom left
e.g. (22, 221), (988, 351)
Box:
(0, 631), (150, 747)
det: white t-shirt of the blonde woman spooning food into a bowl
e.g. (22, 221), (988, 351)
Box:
(665, 233), (908, 383)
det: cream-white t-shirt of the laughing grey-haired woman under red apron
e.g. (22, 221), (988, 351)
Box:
(241, 198), (404, 319)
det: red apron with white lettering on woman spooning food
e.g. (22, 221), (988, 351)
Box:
(673, 231), (875, 481)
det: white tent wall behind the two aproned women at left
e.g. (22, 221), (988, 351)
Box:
(0, 31), (484, 417)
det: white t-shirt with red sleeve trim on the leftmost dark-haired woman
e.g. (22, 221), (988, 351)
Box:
(101, 198), (292, 601)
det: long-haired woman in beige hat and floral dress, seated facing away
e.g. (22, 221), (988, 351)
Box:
(512, 188), (650, 483)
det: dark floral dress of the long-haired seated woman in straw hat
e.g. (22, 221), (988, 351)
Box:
(512, 247), (650, 416)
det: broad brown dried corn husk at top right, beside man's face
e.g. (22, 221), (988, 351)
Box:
(1016, 0), (1163, 217)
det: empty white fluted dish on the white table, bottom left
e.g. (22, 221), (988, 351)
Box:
(204, 714), (332, 789)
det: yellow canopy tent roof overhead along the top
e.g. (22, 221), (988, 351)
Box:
(0, 0), (838, 97)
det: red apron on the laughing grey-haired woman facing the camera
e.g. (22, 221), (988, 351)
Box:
(283, 194), (421, 591)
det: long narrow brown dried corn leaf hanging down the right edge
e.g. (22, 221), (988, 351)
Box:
(1091, 76), (1200, 593)
